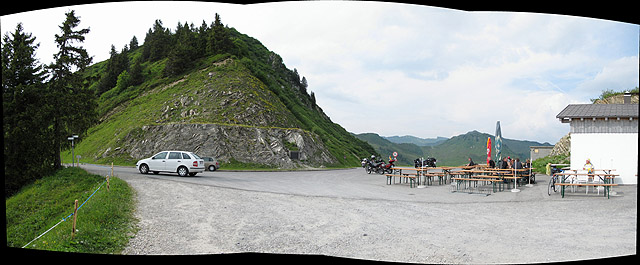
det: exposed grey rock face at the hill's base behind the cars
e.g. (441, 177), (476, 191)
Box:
(119, 124), (336, 168)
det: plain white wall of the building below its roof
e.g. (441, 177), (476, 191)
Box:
(571, 132), (638, 184)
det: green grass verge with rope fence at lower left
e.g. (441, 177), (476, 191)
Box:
(5, 167), (137, 254)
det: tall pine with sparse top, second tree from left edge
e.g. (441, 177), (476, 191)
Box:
(47, 10), (96, 168)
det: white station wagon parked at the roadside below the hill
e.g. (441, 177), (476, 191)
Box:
(136, 151), (204, 177)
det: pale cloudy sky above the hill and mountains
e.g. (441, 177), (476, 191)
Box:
(0, 1), (640, 144)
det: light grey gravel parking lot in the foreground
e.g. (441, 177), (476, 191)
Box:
(83, 165), (637, 263)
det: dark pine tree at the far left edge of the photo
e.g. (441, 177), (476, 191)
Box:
(2, 24), (55, 196)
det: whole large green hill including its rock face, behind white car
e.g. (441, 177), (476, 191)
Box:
(70, 18), (374, 168)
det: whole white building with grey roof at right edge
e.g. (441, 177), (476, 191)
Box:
(556, 95), (639, 184)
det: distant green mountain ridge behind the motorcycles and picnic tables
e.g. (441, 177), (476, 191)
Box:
(356, 130), (553, 166)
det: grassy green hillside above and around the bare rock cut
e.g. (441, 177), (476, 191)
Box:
(69, 23), (374, 167)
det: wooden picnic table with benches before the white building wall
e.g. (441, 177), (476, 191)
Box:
(554, 169), (619, 198)
